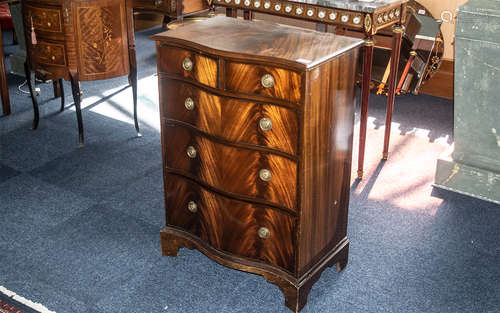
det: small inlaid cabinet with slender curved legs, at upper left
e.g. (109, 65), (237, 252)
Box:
(22, 0), (139, 145)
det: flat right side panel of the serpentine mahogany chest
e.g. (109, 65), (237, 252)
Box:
(297, 50), (358, 273)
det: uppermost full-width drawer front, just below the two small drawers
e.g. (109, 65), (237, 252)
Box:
(160, 79), (298, 155)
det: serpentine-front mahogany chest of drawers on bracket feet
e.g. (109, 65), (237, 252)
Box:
(153, 17), (363, 312)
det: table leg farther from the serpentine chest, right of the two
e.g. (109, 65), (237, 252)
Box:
(382, 25), (404, 160)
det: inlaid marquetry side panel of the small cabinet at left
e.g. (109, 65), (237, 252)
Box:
(76, 1), (129, 80)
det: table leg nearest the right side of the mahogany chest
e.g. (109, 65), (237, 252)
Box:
(358, 37), (375, 179)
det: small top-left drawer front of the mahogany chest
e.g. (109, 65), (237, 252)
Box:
(158, 46), (218, 88)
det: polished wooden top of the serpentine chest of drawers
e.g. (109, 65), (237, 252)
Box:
(151, 16), (364, 70)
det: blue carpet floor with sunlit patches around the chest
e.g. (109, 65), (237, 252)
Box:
(0, 29), (500, 313)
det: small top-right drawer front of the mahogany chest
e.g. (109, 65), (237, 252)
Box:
(226, 62), (302, 103)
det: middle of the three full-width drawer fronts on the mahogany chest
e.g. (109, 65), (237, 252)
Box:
(163, 126), (297, 211)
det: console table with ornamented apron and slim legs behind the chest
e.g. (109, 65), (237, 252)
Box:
(215, 0), (408, 178)
